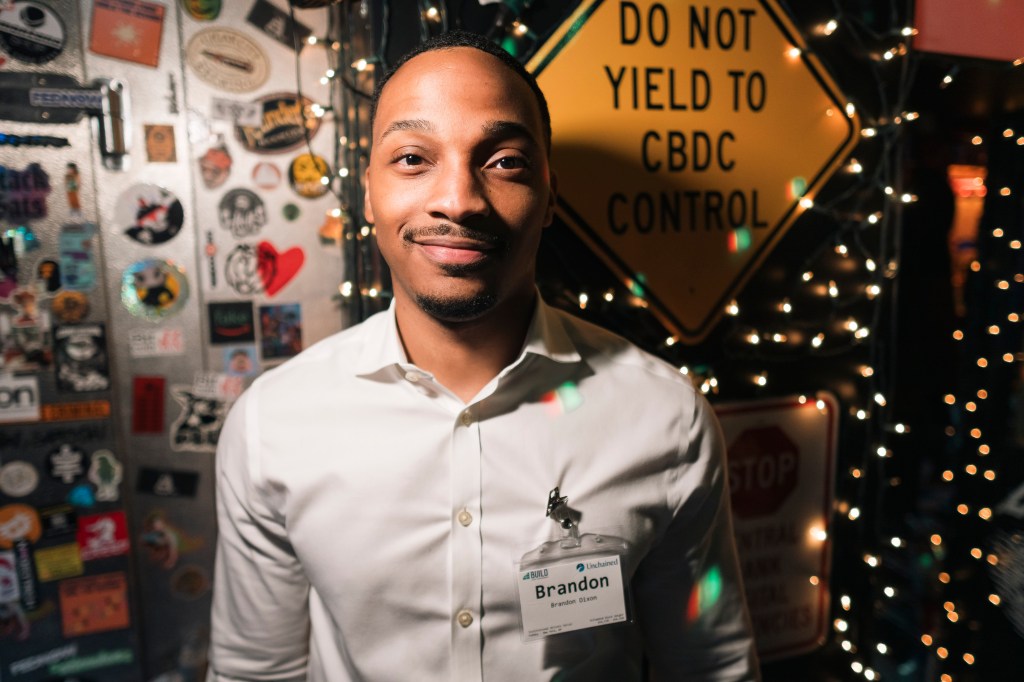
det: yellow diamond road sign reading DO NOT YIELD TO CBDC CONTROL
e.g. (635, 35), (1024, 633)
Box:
(528, 0), (858, 343)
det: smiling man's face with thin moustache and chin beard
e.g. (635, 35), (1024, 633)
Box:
(366, 47), (554, 322)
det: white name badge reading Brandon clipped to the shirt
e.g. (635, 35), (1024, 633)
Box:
(517, 554), (628, 642)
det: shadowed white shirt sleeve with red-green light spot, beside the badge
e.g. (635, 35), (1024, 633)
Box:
(633, 394), (760, 682)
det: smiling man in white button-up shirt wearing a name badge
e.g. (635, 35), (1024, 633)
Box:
(210, 33), (757, 682)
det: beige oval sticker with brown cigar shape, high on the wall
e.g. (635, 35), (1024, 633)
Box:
(185, 29), (270, 92)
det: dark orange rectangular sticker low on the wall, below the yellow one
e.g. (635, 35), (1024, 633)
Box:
(60, 572), (130, 637)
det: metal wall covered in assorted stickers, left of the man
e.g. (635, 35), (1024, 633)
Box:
(0, 0), (352, 682)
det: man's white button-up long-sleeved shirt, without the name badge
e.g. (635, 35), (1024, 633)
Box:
(208, 301), (758, 682)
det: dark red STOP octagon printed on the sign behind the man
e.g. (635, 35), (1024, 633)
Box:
(729, 426), (800, 518)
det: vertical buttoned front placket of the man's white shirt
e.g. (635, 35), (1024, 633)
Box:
(451, 406), (483, 682)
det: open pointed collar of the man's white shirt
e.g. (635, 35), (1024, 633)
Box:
(355, 293), (582, 377)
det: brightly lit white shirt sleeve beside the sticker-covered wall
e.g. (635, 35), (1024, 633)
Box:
(207, 389), (309, 682)
